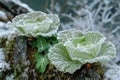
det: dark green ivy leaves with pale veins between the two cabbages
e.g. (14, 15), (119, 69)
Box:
(32, 36), (58, 73)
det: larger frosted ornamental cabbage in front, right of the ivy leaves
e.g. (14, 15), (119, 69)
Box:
(48, 29), (116, 74)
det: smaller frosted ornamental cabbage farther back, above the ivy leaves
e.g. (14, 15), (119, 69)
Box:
(6, 11), (60, 37)
